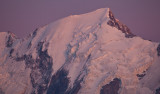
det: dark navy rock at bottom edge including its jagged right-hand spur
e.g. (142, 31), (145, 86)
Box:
(47, 69), (83, 94)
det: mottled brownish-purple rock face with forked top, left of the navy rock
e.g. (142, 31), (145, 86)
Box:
(15, 42), (53, 94)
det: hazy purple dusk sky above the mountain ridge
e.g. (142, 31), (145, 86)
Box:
(0, 0), (160, 42)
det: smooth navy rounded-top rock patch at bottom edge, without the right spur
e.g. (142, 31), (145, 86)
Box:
(47, 69), (69, 94)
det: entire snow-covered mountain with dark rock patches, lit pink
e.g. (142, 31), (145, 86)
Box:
(0, 8), (160, 94)
